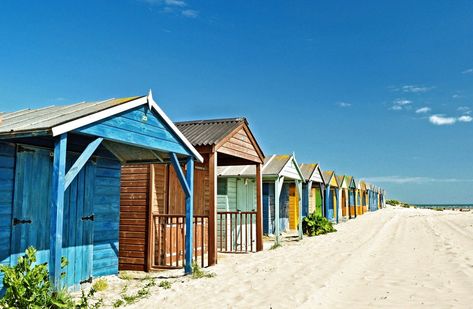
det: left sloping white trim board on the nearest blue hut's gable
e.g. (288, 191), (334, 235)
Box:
(52, 97), (148, 136)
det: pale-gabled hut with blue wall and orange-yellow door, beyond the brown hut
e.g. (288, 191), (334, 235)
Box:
(217, 155), (304, 242)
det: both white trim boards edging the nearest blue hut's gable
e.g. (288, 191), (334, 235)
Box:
(52, 90), (204, 163)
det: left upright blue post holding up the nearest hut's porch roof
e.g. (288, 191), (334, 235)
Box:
(49, 133), (67, 290)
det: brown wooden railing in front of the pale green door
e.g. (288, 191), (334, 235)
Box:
(217, 211), (256, 253)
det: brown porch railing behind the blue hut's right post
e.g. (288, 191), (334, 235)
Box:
(151, 214), (209, 268)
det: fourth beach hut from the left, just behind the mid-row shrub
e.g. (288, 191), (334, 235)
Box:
(299, 163), (324, 217)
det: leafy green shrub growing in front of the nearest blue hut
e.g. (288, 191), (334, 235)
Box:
(0, 247), (74, 308)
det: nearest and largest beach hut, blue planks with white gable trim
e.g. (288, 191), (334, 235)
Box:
(0, 92), (202, 288)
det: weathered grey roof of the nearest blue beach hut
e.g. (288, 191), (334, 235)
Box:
(0, 97), (140, 134)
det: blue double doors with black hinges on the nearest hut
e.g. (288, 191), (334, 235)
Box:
(10, 146), (95, 286)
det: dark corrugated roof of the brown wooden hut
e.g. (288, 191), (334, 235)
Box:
(175, 117), (248, 146)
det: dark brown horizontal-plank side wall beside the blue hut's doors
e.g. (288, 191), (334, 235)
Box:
(119, 165), (148, 271)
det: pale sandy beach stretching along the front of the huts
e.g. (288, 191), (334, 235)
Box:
(127, 207), (473, 308)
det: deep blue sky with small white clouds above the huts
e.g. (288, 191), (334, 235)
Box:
(0, 0), (473, 203)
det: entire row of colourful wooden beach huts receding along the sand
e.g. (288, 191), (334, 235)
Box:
(0, 92), (385, 289)
